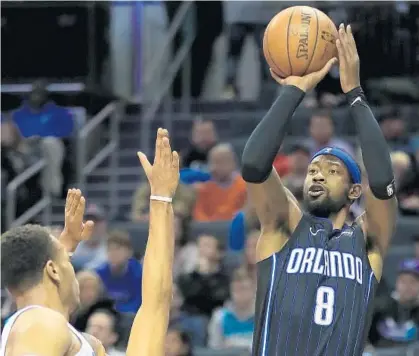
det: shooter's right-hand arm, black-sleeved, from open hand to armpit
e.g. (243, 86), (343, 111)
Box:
(337, 25), (397, 279)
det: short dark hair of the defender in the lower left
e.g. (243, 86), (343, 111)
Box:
(1, 224), (57, 292)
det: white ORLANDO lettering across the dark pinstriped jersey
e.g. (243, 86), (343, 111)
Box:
(286, 247), (363, 284)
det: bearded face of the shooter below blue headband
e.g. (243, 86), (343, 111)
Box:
(304, 155), (361, 218)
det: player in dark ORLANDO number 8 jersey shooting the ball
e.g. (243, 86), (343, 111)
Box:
(242, 25), (397, 356)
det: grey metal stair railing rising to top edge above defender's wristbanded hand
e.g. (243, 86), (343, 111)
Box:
(140, 1), (196, 154)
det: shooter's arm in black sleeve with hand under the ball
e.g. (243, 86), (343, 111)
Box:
(242, 59), (335, 261)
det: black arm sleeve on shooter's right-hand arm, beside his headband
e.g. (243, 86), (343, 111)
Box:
(346, 87), (396, 200)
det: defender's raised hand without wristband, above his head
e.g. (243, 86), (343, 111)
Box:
(60, 189), (94, 252)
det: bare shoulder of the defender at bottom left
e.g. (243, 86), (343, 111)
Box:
(7, 308), (71, 356)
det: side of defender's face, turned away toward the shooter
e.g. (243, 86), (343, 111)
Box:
(51, 235), (80, 312)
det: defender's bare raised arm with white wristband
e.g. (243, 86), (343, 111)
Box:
(126, 129), (179, 356)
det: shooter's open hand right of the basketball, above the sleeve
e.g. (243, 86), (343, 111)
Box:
(336, 24), (361, 93)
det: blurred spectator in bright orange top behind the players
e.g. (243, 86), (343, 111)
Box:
(194, 144), (247, 221)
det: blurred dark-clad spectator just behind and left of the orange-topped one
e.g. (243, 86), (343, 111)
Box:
(184, 119), (218, 169)
